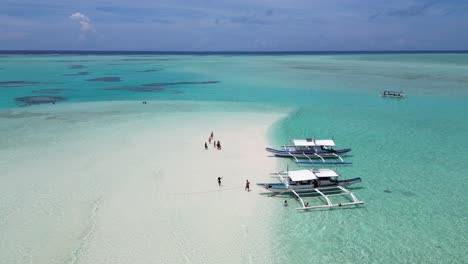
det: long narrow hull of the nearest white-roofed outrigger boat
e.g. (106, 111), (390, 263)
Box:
(257, 177), (362, 193)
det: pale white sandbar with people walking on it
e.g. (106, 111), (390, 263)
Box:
(0, 102), (285, 264)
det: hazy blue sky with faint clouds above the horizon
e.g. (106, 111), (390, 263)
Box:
(0, 0), (468, 51)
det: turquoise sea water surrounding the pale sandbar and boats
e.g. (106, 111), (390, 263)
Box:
(0, 53), (468, 263)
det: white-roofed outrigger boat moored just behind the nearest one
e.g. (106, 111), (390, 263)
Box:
(266, 138), (351, 164)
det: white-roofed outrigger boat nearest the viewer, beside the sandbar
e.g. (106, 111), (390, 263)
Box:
(257, 169), (364, 210)
